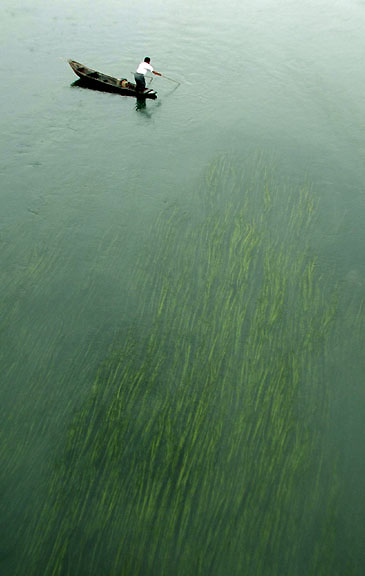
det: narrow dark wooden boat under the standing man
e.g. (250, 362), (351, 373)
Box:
(68, 60), (157, 100)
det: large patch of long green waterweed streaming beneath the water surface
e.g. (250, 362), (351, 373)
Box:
(9, 156), (346, 576)
